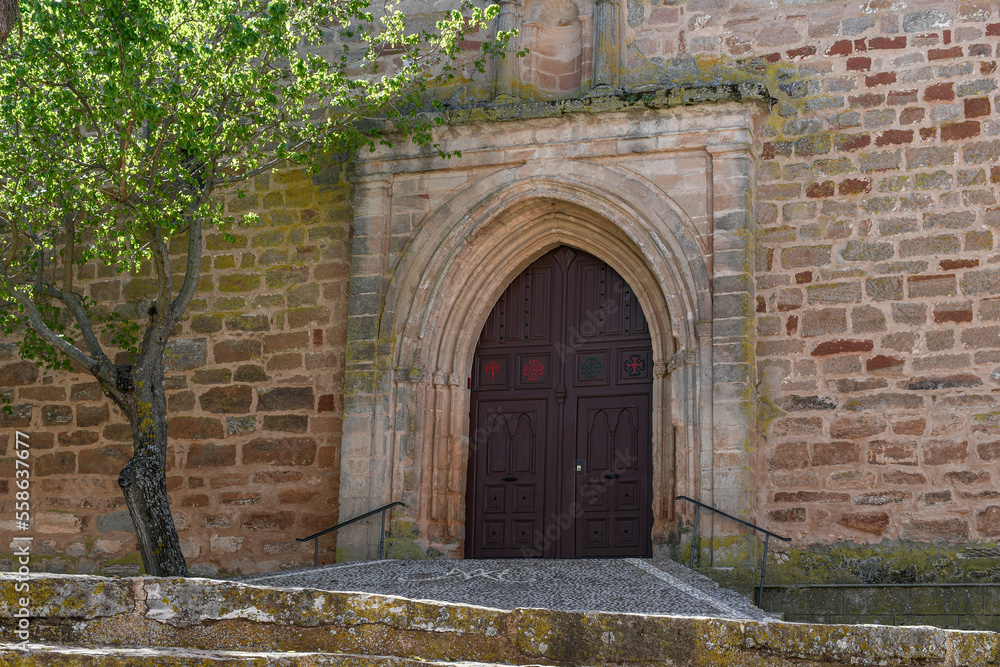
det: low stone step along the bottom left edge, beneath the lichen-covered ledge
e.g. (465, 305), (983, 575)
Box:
(0, 644), (520, 667)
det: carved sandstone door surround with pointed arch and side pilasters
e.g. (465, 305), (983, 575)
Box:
(338, 105), (755, 559)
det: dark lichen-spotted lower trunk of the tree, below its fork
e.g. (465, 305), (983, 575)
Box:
(116, 349), (188, 577)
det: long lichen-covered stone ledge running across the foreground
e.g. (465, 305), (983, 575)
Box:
(0, 575), (1000, 667)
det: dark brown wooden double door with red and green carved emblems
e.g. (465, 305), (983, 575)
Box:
(466, 246), (653, 558)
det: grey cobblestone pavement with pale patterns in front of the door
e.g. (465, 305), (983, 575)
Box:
(242, 558), (766, 619)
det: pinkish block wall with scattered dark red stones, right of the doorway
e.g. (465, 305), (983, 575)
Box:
(588, 0), (1000, 544)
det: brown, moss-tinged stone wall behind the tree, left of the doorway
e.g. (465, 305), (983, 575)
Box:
(0, 166), (351, 574)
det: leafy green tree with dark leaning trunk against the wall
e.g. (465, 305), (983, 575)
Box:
(0, 0), (506, 575)
